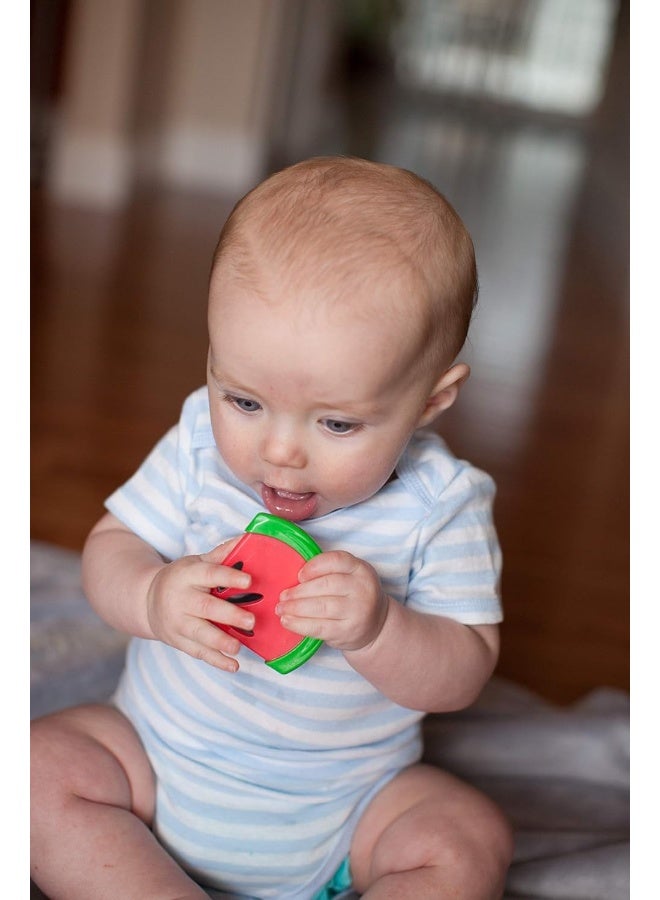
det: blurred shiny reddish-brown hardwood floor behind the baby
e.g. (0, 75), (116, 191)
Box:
(31, 15), (629, 702)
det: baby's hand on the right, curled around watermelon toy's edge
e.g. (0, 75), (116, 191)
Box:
(275, 550), (389, 650)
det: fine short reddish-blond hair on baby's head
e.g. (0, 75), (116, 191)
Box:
(212, 157), (478, 368)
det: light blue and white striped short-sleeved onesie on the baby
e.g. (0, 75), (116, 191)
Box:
(106, 387), (502, 900)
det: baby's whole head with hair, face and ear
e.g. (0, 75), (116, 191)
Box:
(209, 158), (477, 520)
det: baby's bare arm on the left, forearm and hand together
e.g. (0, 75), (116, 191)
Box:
(82, 513), (254, 671)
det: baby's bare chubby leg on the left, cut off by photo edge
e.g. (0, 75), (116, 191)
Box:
(31, 706), (207, 900)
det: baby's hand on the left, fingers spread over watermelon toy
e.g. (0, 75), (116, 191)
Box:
(147, 539), (254, 672)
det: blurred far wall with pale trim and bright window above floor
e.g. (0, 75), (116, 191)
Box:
(31, 0), (622, 204)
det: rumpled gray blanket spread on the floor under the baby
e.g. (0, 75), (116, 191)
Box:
(31, 543), (629, 900)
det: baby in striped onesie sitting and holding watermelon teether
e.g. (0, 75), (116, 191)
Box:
(32, 158), (511, 900)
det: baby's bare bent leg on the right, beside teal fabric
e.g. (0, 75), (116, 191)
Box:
(351, 765), (513, 900)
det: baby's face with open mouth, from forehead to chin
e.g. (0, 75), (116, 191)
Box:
(208, 268), (430, 521)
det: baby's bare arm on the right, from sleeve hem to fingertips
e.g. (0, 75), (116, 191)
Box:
(278, 551), (499, 712)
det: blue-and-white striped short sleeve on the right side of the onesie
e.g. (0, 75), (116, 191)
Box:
(407, 466), (502, 625)
